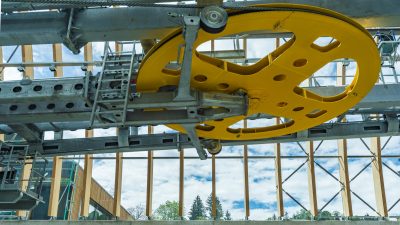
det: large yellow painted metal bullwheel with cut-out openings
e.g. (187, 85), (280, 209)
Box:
(137, 4), (380, 140)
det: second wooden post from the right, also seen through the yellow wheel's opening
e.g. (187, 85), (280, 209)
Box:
(336, 62), (353, 217)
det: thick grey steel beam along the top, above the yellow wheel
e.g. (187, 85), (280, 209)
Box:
(0, 0), (400, 49)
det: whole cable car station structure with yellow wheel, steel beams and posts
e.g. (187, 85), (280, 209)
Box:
(0, 0), (400, 222)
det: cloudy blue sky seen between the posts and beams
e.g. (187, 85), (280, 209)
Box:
(3, 33), (400, 220)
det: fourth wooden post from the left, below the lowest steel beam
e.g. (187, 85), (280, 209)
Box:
(113, 152), (123, 218)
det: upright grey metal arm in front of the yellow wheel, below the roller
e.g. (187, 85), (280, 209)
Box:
(174, 16), (200, 101)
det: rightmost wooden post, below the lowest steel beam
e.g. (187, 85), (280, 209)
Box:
(371, 137), (388, 217)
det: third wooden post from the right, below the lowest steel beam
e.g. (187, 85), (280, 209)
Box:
(306, 141), (318, 217)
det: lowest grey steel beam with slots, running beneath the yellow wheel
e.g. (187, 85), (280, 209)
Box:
(2, 118), (400, 157)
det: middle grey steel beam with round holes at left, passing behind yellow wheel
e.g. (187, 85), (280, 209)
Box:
(0, 78), (400, 133)
